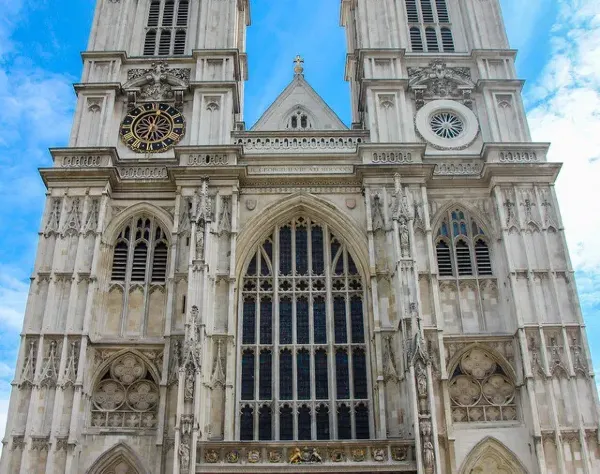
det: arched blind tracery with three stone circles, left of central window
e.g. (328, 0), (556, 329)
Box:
(91, 353), (159, 429)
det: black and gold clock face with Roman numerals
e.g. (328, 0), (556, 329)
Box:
(119, 103), (185, 153)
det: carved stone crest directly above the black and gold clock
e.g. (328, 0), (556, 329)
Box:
(123, 61), (191, 110)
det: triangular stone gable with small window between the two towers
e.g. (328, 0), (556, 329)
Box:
(251, 74), (348, 131)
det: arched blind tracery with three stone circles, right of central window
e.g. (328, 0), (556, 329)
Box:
(448, 347), (518, 422)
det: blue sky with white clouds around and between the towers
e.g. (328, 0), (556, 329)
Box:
(0, 0), (600, 442)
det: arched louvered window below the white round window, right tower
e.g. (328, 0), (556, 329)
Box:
(435, 209), (493, 277)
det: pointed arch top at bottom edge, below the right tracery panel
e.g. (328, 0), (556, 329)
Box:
(460, 438), (527, 474)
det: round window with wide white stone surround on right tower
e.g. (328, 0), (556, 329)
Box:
(415, 100), (479, 150)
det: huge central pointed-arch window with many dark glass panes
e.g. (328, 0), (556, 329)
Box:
(238, 217), (372, 440)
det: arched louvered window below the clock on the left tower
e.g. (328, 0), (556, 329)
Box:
(111, 217), (168, 286)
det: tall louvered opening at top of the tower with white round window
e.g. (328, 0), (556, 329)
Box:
(405, 0), (455, 53)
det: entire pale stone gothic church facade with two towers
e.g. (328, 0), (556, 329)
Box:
(0, 0), (600, 474)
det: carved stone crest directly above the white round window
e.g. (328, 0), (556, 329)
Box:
(408, 60), (475, 109)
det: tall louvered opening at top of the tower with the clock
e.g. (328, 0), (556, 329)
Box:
(143, 0), (190, 56)
